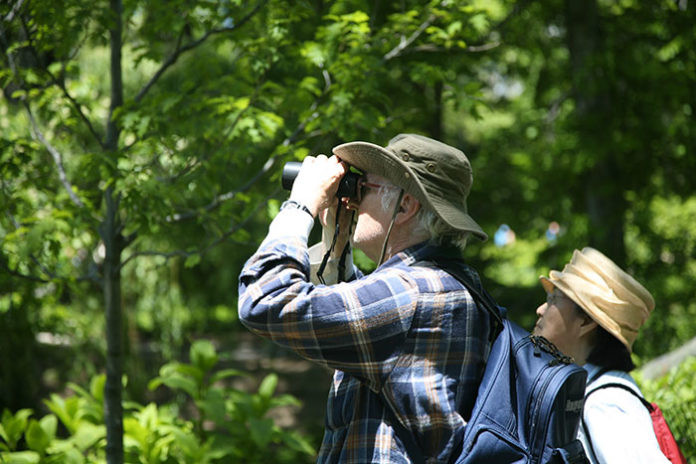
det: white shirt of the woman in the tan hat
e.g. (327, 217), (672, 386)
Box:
(578, 364), (670, 464)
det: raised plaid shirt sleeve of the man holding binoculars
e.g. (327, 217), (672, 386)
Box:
(239, 220), (418, 391)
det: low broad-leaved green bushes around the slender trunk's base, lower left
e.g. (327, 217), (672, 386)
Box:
(0, 341), (315, 464)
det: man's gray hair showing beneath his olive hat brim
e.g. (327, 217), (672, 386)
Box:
(379, 186), (471, 252)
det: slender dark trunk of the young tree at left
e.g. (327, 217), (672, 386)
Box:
(99, 0), (124, 464)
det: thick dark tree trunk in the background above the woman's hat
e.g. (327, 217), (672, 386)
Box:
(566, 0), (627, 267)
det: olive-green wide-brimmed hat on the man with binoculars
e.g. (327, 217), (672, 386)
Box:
(333, 130), (488, 240)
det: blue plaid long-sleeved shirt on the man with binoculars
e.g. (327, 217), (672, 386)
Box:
(239, 237), (490, 463)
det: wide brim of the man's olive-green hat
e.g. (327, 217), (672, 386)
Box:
(333, 142), (488, 241)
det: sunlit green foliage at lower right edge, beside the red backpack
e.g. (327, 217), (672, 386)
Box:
(636, 357), (696, 462)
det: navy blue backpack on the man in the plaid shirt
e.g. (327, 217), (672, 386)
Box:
(407, 260), (588, 464)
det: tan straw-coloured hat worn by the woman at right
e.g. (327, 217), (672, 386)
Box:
(539, 247), (655, 352)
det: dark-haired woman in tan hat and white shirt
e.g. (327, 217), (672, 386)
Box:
(534, 247), (669, 464)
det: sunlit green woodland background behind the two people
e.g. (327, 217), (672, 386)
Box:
(0, 0), (696, 463)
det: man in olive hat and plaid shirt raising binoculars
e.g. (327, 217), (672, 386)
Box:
(239, 134), (491, 463)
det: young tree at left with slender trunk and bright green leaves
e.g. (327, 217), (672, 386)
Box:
(0, 0), (506, 462)
